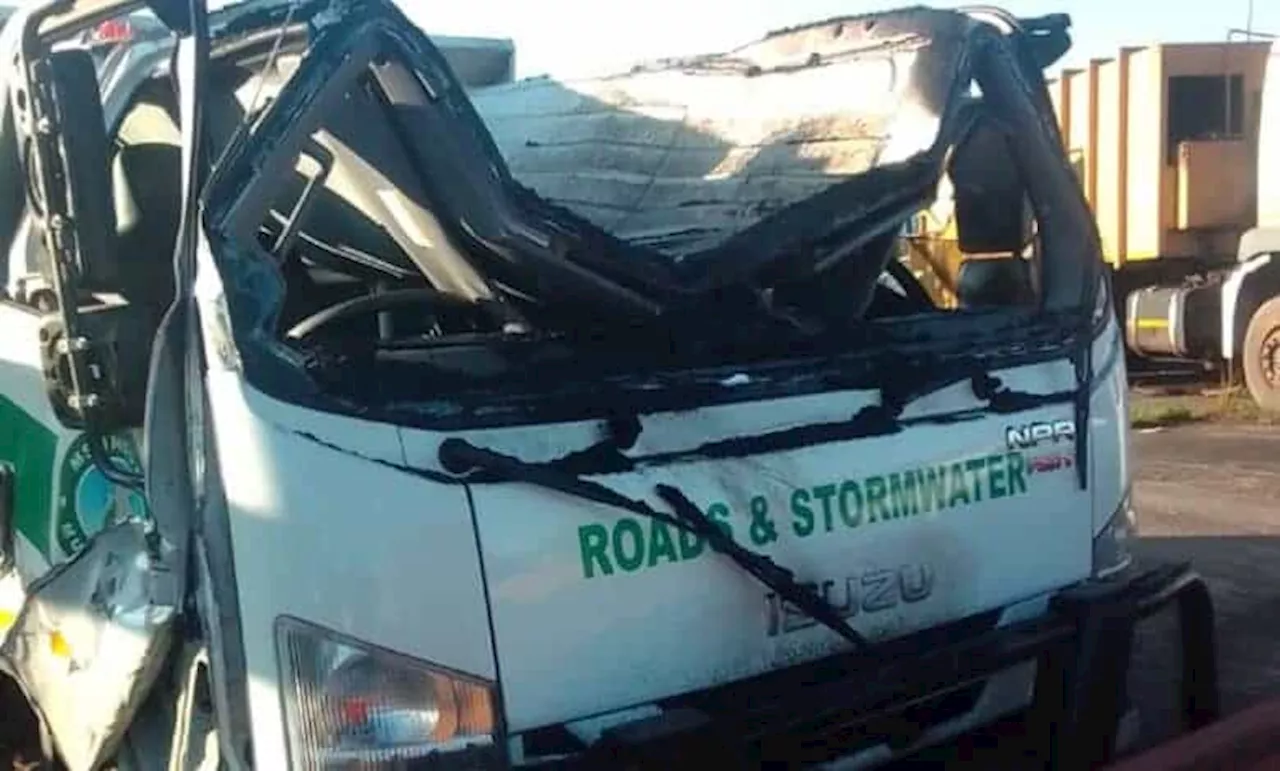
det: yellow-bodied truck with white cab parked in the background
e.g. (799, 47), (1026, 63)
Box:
(1050, 36), (1280, 410)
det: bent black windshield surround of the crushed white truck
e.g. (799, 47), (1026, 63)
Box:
(197, 3), (1106, 430)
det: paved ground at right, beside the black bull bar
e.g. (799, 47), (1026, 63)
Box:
(1134, 424), (1280, 742)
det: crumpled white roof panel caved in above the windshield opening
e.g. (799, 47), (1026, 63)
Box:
(472, 10), (964, 255)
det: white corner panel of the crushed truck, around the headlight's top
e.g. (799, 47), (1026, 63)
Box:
(207, 371), (497, 768)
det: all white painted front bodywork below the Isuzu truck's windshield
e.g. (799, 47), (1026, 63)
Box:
(194, 307), (1128, 767)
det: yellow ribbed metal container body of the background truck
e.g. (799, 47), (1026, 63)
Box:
(1050, 42), (1271, 268)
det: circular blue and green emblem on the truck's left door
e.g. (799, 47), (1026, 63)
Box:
(54, 434), (147, 556)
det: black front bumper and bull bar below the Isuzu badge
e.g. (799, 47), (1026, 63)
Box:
(526, 565), (1219, 771)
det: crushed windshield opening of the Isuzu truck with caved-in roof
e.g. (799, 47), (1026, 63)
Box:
(185, 1), (1094, 420)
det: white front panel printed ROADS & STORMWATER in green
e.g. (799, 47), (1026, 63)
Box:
(403, 345), (1092, 731)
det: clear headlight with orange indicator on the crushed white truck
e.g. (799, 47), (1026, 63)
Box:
(276, 617), (498, 771)
